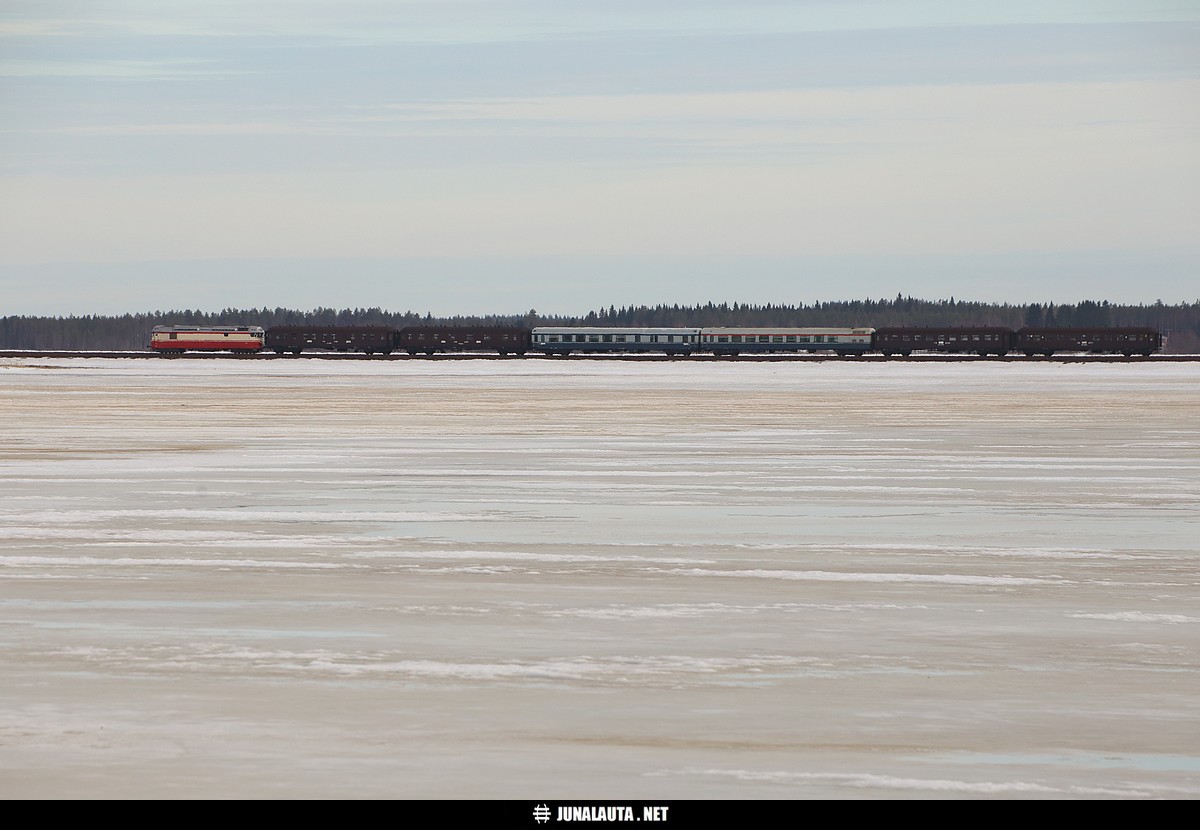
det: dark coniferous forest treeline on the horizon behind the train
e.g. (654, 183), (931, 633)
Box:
(0, 295), (1200, 354)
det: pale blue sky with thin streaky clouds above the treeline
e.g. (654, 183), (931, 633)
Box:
(0, 0), (1200, 317)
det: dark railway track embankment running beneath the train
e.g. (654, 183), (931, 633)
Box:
(0, 350), (1200, 363)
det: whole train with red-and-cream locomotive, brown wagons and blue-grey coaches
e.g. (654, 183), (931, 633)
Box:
(150, 325), (1164, 357)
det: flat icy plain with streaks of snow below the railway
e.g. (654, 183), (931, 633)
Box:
(0, 359), (1200, 802)
